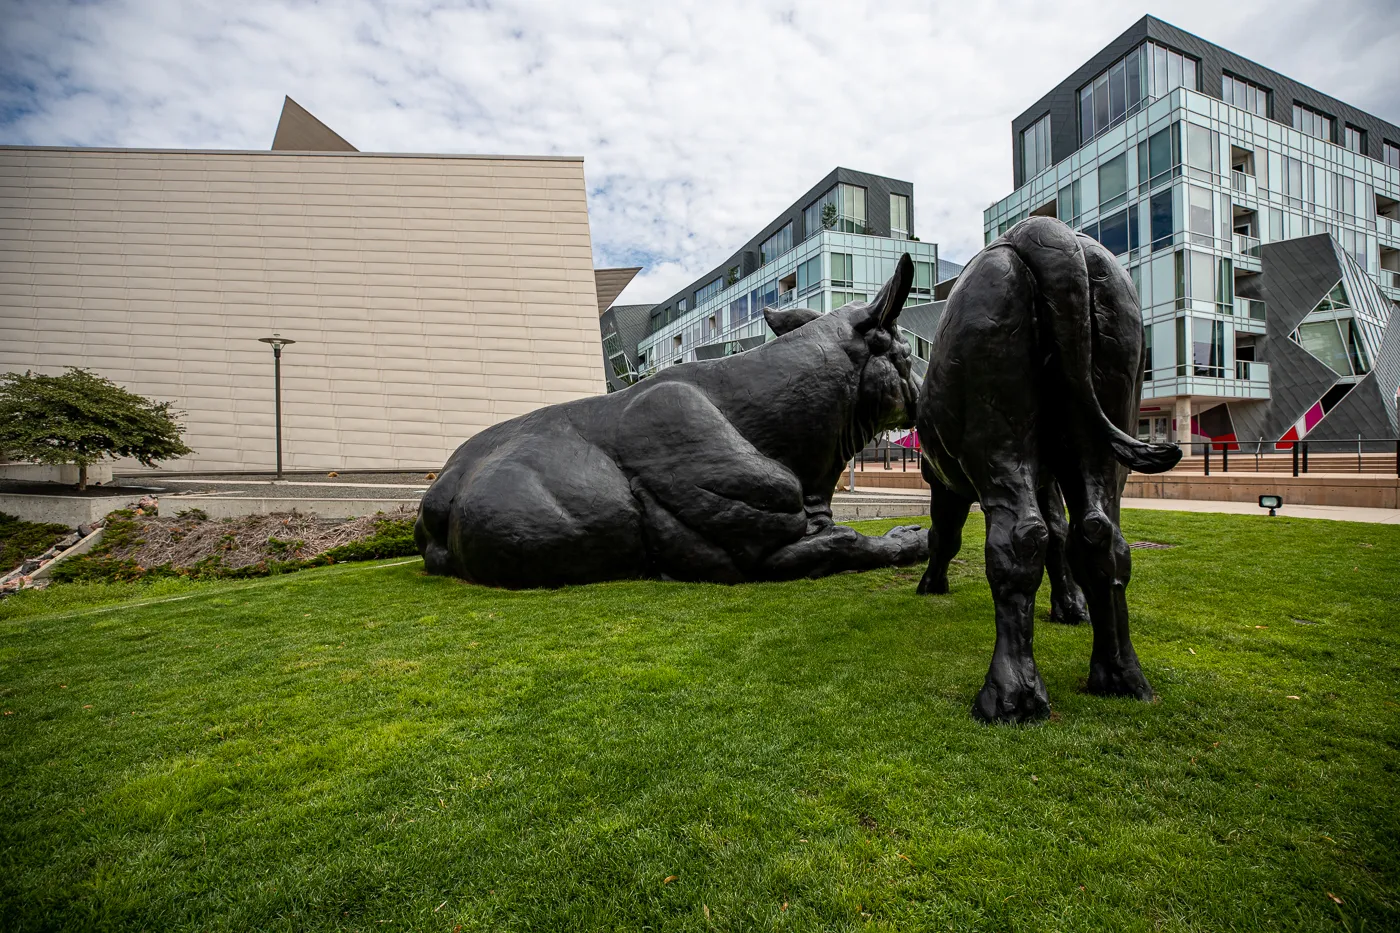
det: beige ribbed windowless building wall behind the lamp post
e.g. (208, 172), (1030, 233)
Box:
(0, 147), (603, 469)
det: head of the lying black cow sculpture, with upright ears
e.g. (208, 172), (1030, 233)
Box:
(763, 252), (918, 442)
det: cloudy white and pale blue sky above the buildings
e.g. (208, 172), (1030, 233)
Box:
(0, 0), (1400, 301)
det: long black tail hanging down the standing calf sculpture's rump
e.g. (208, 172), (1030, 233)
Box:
(1005, 217), (1182, 474)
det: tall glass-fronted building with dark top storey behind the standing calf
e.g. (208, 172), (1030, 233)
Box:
(983, 18), (1400, 440)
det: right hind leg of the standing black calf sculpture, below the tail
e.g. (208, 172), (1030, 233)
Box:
(1064, 462), (1152, 700)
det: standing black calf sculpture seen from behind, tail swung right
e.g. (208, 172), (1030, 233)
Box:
(918, 217), (1182, 721)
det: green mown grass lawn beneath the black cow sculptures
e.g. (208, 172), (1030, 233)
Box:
(0, 511), (1400, 933)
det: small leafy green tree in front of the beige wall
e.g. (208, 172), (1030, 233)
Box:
(0, 367), (192, 489)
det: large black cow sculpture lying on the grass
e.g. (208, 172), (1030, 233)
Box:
(414, 255), (928, 587)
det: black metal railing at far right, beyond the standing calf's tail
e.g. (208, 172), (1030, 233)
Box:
(1186, 434), (1400, 476)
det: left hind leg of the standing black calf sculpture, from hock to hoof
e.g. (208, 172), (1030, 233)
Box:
(972, 474), (1050, 723)
